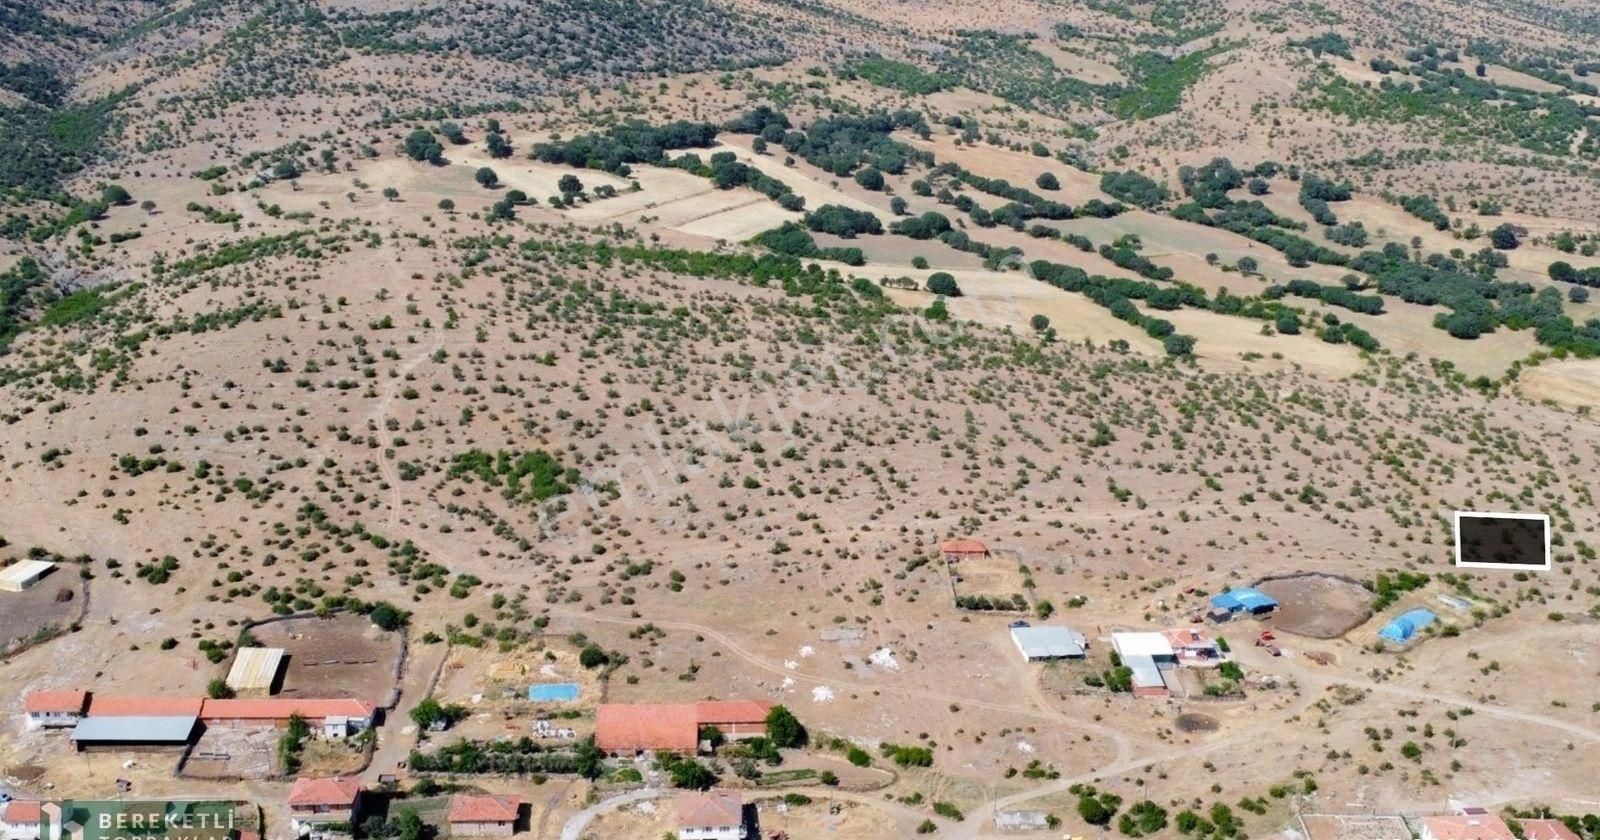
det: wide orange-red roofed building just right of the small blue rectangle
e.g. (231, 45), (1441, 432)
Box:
(595, 701), (773, 754)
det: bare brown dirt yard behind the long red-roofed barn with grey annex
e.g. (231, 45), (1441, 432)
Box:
(250, 613), (402, 706)
